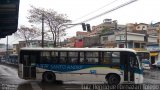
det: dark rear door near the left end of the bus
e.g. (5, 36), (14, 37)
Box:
(23, 55), (36, 79)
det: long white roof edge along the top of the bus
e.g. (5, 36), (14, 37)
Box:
(21, 48), (136, 53)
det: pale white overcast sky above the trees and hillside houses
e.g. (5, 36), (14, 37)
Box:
(0, 0), (160, 44)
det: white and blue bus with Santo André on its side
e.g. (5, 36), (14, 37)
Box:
(18, 48), (143, 84)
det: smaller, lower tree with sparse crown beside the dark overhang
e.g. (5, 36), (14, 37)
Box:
(14, 25), (41, 46)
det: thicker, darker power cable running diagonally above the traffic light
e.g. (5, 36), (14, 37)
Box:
(66, 0), (138, 29)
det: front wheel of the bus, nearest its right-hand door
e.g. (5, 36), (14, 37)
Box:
(107, 74), (120, 85)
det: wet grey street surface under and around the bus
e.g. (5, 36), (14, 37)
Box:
(0, 64), (160, 90)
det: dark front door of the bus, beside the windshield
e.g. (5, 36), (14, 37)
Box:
(122, 53), (134, 83)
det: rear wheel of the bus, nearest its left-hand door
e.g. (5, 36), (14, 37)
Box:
(42, 72), (56, 83)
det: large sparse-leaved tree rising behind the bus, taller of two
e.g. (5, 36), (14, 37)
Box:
(28, 6), (71, 47)
